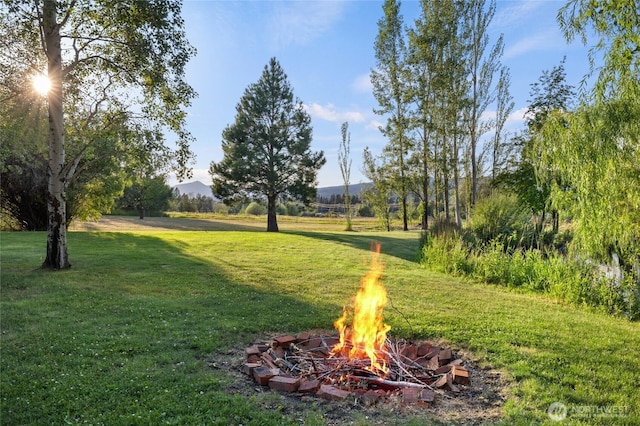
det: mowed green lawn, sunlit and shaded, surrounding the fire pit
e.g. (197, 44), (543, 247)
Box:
(0, 219), (640, 425)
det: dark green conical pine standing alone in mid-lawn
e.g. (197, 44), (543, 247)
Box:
(209, 58), (326, 232)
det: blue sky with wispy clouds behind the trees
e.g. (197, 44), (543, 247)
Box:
(169, 0), (589, 187)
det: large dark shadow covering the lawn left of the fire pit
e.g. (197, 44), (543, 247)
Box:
(0, 232), (339, 424)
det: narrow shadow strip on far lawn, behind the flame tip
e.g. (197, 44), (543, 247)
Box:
(282, 230), (420, 262)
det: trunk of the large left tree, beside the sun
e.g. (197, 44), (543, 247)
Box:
(42, 0), (71, 269)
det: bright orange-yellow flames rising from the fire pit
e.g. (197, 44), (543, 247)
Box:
(332, 243), (391, 374)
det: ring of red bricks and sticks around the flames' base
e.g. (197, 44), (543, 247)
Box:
(242, 333), (470, 407)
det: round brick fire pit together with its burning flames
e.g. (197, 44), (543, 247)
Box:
(242, 244), (470, 406)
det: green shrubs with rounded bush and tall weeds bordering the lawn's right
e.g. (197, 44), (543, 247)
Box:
(422, 193), (640, 320)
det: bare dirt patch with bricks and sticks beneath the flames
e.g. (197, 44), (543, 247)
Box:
(209, 332), (506, 425)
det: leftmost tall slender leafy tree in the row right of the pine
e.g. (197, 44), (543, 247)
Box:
(371, 0), (411, 231)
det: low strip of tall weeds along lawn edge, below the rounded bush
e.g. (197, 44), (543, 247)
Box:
(422, 230), (640, 320)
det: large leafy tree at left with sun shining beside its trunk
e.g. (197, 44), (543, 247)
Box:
(0, 0), (195, 269)
